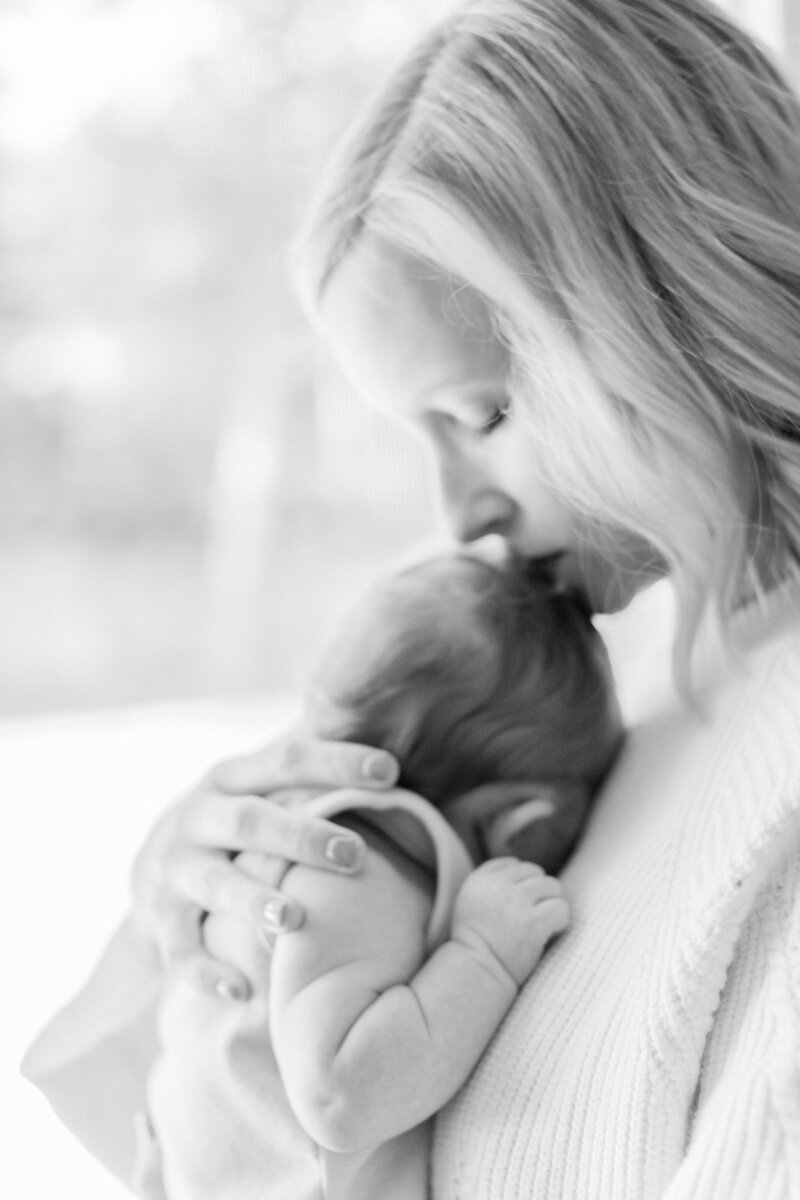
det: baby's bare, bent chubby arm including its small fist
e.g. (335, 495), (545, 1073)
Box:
(270, 829), (567, 1151)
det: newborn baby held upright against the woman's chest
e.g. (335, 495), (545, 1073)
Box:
(150, 553), (620, 1200)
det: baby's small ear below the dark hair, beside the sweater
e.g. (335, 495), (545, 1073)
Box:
(503, 781), (589, 875)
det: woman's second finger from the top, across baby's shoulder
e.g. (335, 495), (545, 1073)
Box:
(184, 792), (366, 872)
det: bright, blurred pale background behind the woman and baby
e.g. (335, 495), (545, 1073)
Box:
(0, 0), (800, 1200)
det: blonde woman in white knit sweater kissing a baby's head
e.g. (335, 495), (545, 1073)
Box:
(21, 0), (800, 1200)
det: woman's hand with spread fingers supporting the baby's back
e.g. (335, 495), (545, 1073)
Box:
(132, 734), (398, 1000)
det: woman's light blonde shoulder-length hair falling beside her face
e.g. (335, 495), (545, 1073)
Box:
(295, 0), (800, 678)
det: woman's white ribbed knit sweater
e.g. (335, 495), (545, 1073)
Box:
(434, 576), (800, 1200)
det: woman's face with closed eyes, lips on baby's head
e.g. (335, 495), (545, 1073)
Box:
(321, 240), (657, 612)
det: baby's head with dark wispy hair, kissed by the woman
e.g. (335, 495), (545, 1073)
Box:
(307, 551), (621, 869)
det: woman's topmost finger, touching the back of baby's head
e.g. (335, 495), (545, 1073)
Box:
(209, 733), (399, 796)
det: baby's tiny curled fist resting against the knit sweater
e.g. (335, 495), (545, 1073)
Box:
(450, 858), (570, 986)
